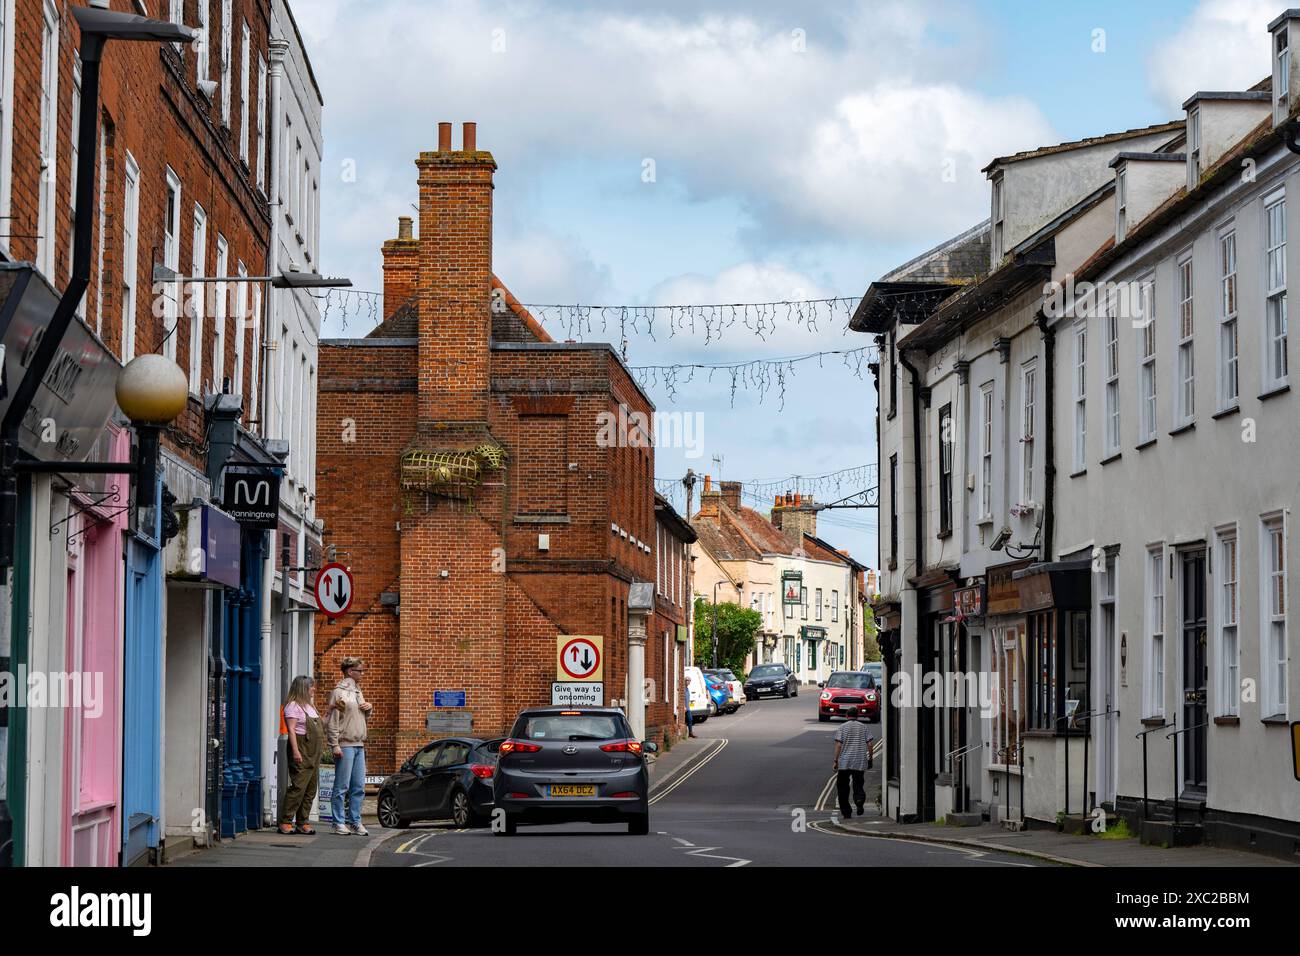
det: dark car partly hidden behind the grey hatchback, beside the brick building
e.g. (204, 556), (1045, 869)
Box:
(378, 737), (502, 830)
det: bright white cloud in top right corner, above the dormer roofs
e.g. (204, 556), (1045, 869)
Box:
(1148, 0), (1284, 112)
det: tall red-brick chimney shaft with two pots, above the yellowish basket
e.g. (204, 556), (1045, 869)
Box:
(416, 122), (497, 431)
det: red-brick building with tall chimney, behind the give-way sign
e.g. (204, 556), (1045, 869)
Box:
(317, 124), (680, 769)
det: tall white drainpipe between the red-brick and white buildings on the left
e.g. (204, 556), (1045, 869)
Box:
(261, 29), (293, 826)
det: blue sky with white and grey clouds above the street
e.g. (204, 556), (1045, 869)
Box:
(294, 0), (1284, 564)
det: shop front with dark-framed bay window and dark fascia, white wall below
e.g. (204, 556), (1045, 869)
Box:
(1013, 561), (1092, 822)
